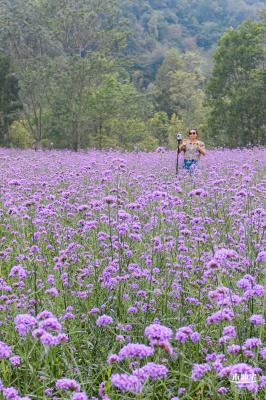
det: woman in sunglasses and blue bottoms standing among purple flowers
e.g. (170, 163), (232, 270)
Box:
(179, 128), (206, 171)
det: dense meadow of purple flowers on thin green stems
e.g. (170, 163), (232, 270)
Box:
(0, 149), (266, 400)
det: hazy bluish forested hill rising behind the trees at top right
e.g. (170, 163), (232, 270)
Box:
(119, 0), (265, 83)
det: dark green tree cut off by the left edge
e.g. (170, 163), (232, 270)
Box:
(0, 55), (22, 144)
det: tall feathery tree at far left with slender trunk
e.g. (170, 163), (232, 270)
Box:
(0, 0), (55, 149)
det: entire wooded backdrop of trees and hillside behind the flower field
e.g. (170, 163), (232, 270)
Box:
(0, 0), (266, 150)
